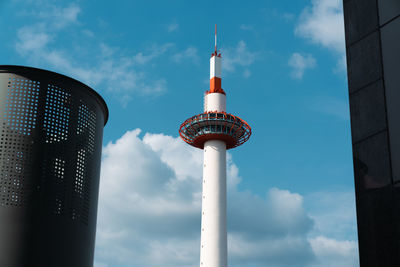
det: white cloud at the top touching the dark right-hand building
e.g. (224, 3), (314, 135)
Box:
(295, 0), (345, 54)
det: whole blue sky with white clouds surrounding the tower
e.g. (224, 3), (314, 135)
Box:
(0, 0), (358, 267)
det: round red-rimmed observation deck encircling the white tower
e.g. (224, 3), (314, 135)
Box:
(179, 112), (251, 149)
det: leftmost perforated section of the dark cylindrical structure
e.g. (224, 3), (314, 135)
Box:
(0, 76), (40, 206)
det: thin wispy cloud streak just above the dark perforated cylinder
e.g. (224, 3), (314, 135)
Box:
(16, 25), (167, 105)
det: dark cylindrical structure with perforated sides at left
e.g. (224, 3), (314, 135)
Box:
(0, 66), (108, 267)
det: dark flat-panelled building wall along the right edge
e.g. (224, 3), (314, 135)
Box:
(343, 0), (400, 267)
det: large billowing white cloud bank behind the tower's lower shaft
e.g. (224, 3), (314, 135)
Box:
(96, 129), (360, 267)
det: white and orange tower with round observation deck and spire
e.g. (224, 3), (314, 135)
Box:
(179, 26), (251, 267)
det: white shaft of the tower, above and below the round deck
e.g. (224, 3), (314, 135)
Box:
(200, 49), (228, 267)
